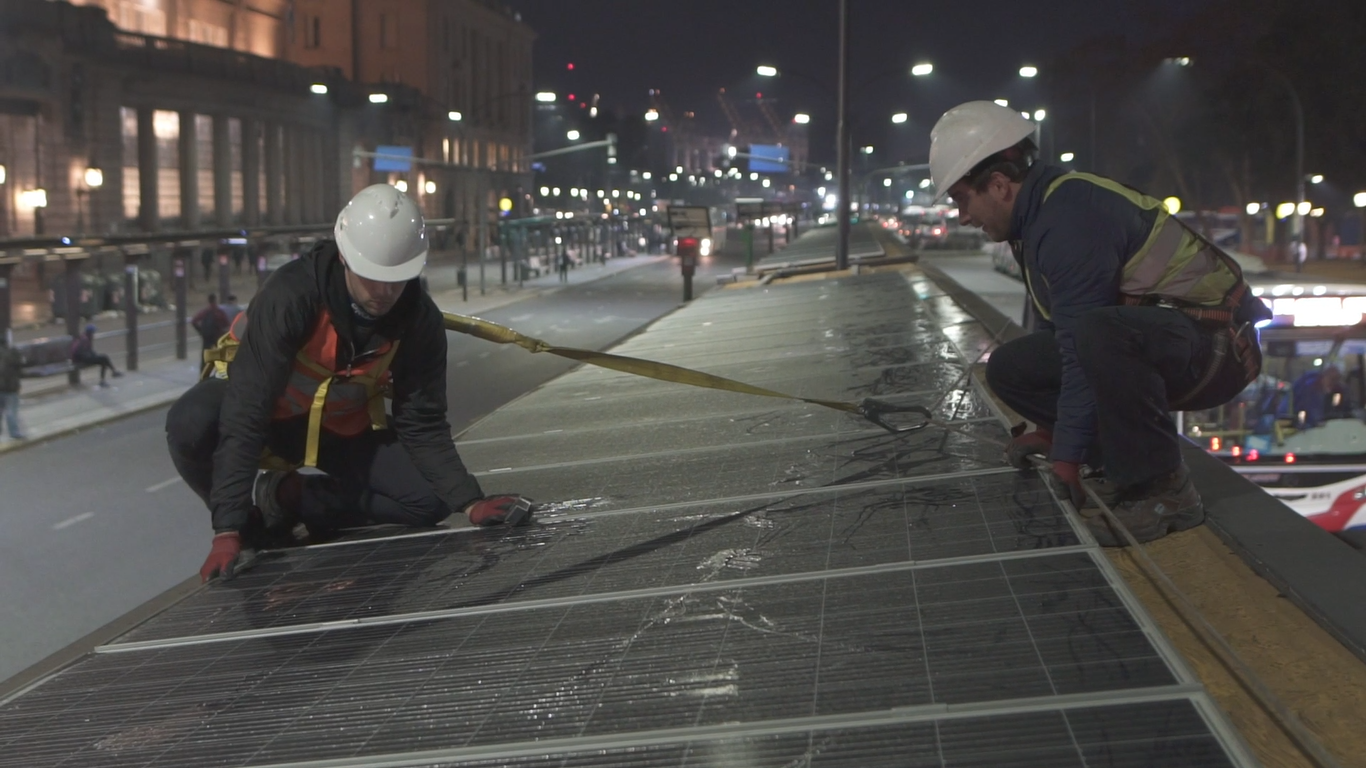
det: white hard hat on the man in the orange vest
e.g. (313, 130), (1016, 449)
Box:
(333, 184), (428, 283)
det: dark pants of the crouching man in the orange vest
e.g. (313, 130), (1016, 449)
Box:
(167, 379), (451, 534)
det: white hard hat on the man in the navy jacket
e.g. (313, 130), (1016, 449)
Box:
(930, 101), (1034, 202)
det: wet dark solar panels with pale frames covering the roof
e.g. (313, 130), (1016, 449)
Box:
(0, 266), (1244, 768)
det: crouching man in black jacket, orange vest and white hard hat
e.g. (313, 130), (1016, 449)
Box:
(167, 184), (531, 581)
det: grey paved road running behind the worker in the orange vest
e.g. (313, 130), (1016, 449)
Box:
(0, 244), (743, 679)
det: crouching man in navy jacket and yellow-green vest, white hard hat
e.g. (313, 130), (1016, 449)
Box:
(930, 101), (1270, 547)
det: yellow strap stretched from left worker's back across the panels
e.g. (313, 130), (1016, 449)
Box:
(441, 312), (933, 435)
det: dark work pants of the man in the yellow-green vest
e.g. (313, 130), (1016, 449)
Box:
(986, 306), (1243, 488)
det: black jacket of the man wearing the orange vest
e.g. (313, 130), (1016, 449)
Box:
(209, 241), (482, 532)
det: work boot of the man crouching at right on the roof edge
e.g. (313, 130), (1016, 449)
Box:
(1086, 465), (1205, 547)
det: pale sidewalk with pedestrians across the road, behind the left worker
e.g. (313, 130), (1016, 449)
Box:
(0, 254), (668, 454)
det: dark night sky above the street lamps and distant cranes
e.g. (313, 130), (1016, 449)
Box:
(511, 0), (1203, 160)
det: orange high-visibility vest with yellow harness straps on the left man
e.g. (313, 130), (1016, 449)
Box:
(202, 309), (399, 466)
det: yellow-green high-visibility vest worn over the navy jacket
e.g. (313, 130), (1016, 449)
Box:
(1023, 174), (1247, 323)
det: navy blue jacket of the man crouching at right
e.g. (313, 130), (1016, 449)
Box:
(1009, 163), (1157, 462)
